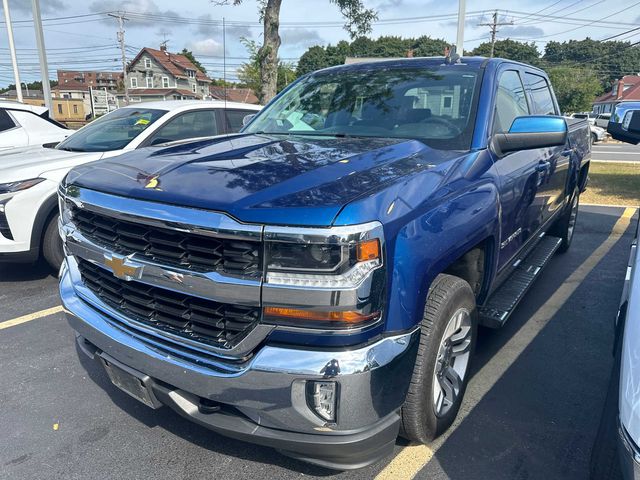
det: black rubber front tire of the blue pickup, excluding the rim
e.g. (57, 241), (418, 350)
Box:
(400, 274), (478, 443)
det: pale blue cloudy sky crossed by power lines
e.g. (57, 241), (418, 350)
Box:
(0, 0), (640, 86)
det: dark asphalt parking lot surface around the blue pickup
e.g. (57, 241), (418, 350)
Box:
(0, 203), (637, 480)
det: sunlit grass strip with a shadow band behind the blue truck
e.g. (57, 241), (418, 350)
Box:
(580, 162), (640, 207)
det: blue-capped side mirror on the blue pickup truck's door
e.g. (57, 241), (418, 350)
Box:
(491, 115), (568, 157)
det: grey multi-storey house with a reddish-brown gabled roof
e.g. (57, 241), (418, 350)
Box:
(123, 46), (211, 102)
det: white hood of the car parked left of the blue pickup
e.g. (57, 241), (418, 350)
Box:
(0, 146), (104, 183)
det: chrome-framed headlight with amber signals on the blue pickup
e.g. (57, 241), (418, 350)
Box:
(263, 222), (385, 329)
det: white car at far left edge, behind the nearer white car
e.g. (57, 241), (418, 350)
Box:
(0, 100), (73, 152)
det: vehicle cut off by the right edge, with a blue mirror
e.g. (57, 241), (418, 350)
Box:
(591, 102), (640, 480)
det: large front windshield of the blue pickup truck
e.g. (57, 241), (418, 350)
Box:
(244, 65), (478, 150)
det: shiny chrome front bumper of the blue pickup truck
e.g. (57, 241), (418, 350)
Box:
(60, 266), (419, 468)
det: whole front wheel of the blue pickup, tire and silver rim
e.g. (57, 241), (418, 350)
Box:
(400, 274), (477, 443)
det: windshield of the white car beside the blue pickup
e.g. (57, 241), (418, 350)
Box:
(56, 108), (167, 152)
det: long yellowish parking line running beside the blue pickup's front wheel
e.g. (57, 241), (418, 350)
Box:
(376, 207), (636, 480)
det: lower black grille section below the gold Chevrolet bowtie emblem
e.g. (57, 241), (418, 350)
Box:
(78, 259), (260, 348)
